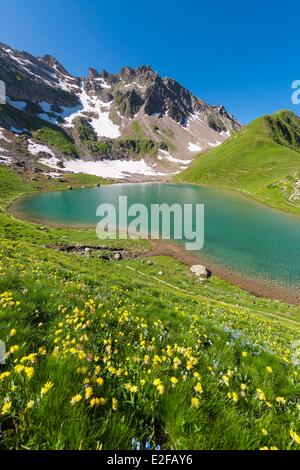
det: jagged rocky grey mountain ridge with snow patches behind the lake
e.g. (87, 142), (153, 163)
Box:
(0, 44), (240, 180)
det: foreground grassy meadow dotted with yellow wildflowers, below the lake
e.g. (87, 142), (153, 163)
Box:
(0, 168), (300, 449)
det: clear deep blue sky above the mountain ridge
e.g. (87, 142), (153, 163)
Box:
(0, 0), (300, 123)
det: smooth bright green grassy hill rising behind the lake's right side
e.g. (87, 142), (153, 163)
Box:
(175, 111), (300, 213)
